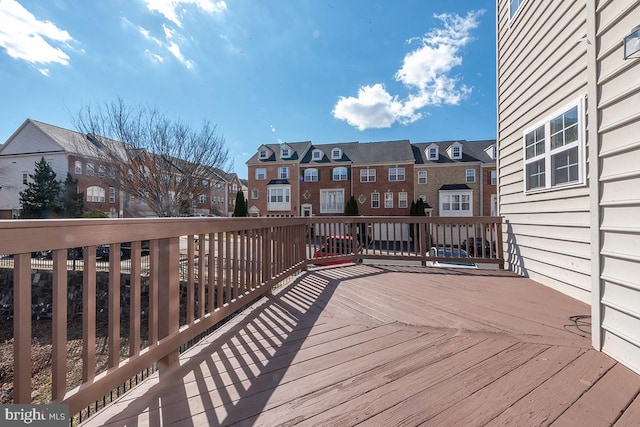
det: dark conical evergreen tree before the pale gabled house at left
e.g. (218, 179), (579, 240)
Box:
(20, 157), (60, 218)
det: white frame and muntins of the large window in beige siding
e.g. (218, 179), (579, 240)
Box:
(522, 97), (587, 194)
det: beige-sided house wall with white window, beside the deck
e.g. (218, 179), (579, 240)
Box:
(497, 0), (640, 373)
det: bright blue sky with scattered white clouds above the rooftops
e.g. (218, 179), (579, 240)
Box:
(0, 0), (496, 178)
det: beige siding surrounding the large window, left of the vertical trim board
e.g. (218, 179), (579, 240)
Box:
(498, 0), (591, 302)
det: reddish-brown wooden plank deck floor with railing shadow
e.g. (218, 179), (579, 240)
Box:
(85, 265), (640, 426)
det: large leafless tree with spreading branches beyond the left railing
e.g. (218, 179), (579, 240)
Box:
(75, 98), (231, 216)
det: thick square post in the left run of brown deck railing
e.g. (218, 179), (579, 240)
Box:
(158, 237), (180, 368)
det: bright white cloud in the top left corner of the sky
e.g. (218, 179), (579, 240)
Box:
(0, 0), (73, 76)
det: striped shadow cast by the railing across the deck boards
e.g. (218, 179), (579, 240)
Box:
(94, 266), (370, 426)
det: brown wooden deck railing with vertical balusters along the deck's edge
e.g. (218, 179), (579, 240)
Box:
(0, 217), (504, 422)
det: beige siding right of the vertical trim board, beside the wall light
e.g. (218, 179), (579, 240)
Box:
(595, 0), (640, 372)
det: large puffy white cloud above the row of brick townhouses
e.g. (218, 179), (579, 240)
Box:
(332, 10), (484, 130)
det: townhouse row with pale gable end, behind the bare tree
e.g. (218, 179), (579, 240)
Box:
(0, 119), (241, 219)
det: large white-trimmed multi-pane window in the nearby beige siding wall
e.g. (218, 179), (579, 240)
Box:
(523, 99), (585, 192)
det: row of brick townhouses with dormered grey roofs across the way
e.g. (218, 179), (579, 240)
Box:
(247, 140), (497, 216)
